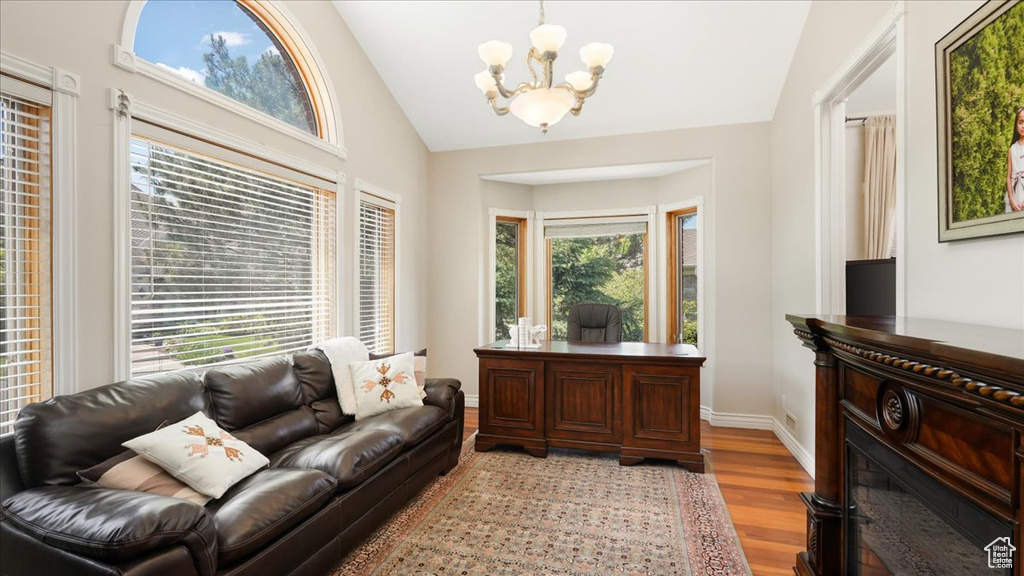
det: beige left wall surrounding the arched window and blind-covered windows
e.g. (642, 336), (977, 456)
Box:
(0, 0), (429, 389)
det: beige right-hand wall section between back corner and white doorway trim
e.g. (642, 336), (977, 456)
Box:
(771, 2), (891, 453)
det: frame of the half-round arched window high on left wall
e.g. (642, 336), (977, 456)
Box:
(112, 0), (348, 160)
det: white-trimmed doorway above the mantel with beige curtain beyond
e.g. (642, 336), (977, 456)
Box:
(814, 6), (906, 316)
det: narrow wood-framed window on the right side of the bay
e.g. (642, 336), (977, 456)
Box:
(667, 208), (698, 345)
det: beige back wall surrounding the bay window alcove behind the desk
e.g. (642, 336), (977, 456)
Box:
(428, 125), (771, 414)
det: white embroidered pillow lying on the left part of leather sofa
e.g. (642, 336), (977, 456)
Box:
(121, 412), (270, 498)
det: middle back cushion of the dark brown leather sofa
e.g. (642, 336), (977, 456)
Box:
(203, 356), (317, 456)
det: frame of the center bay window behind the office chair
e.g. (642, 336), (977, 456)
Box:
(537, 206), (663, 342)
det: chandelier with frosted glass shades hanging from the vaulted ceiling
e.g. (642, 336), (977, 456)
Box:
(473, 0), (613, 134)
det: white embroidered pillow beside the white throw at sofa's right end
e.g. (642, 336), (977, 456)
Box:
(348, 353), (423, 420)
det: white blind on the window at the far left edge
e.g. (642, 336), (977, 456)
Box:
(0, 81), (53, 433)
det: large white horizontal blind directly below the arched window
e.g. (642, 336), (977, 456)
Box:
(131, 134), (336, 375)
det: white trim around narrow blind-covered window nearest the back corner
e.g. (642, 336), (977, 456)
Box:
(351, 178), (402, 354)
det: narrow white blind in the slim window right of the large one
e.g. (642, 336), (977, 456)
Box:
(357, 197), (395, 354)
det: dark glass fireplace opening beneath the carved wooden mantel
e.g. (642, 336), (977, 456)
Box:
(844, 421), (1019, 576)
